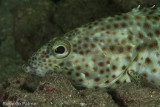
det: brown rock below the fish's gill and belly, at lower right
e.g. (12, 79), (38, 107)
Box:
(114, 82), (160, 107)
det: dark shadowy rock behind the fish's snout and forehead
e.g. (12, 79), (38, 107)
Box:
(12, 0), (61, 60)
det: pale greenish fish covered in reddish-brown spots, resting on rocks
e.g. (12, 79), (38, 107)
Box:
(23, 8), (160, 89)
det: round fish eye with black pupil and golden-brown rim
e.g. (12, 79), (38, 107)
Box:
(52, 41), (71, 59)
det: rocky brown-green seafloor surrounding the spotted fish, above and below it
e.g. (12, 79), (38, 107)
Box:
(0, 0), (160, 107)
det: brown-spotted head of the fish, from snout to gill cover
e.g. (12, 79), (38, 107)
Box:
(23, 27), (131, 88)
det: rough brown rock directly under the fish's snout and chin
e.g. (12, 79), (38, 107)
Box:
(2, 72), (117, 107)
